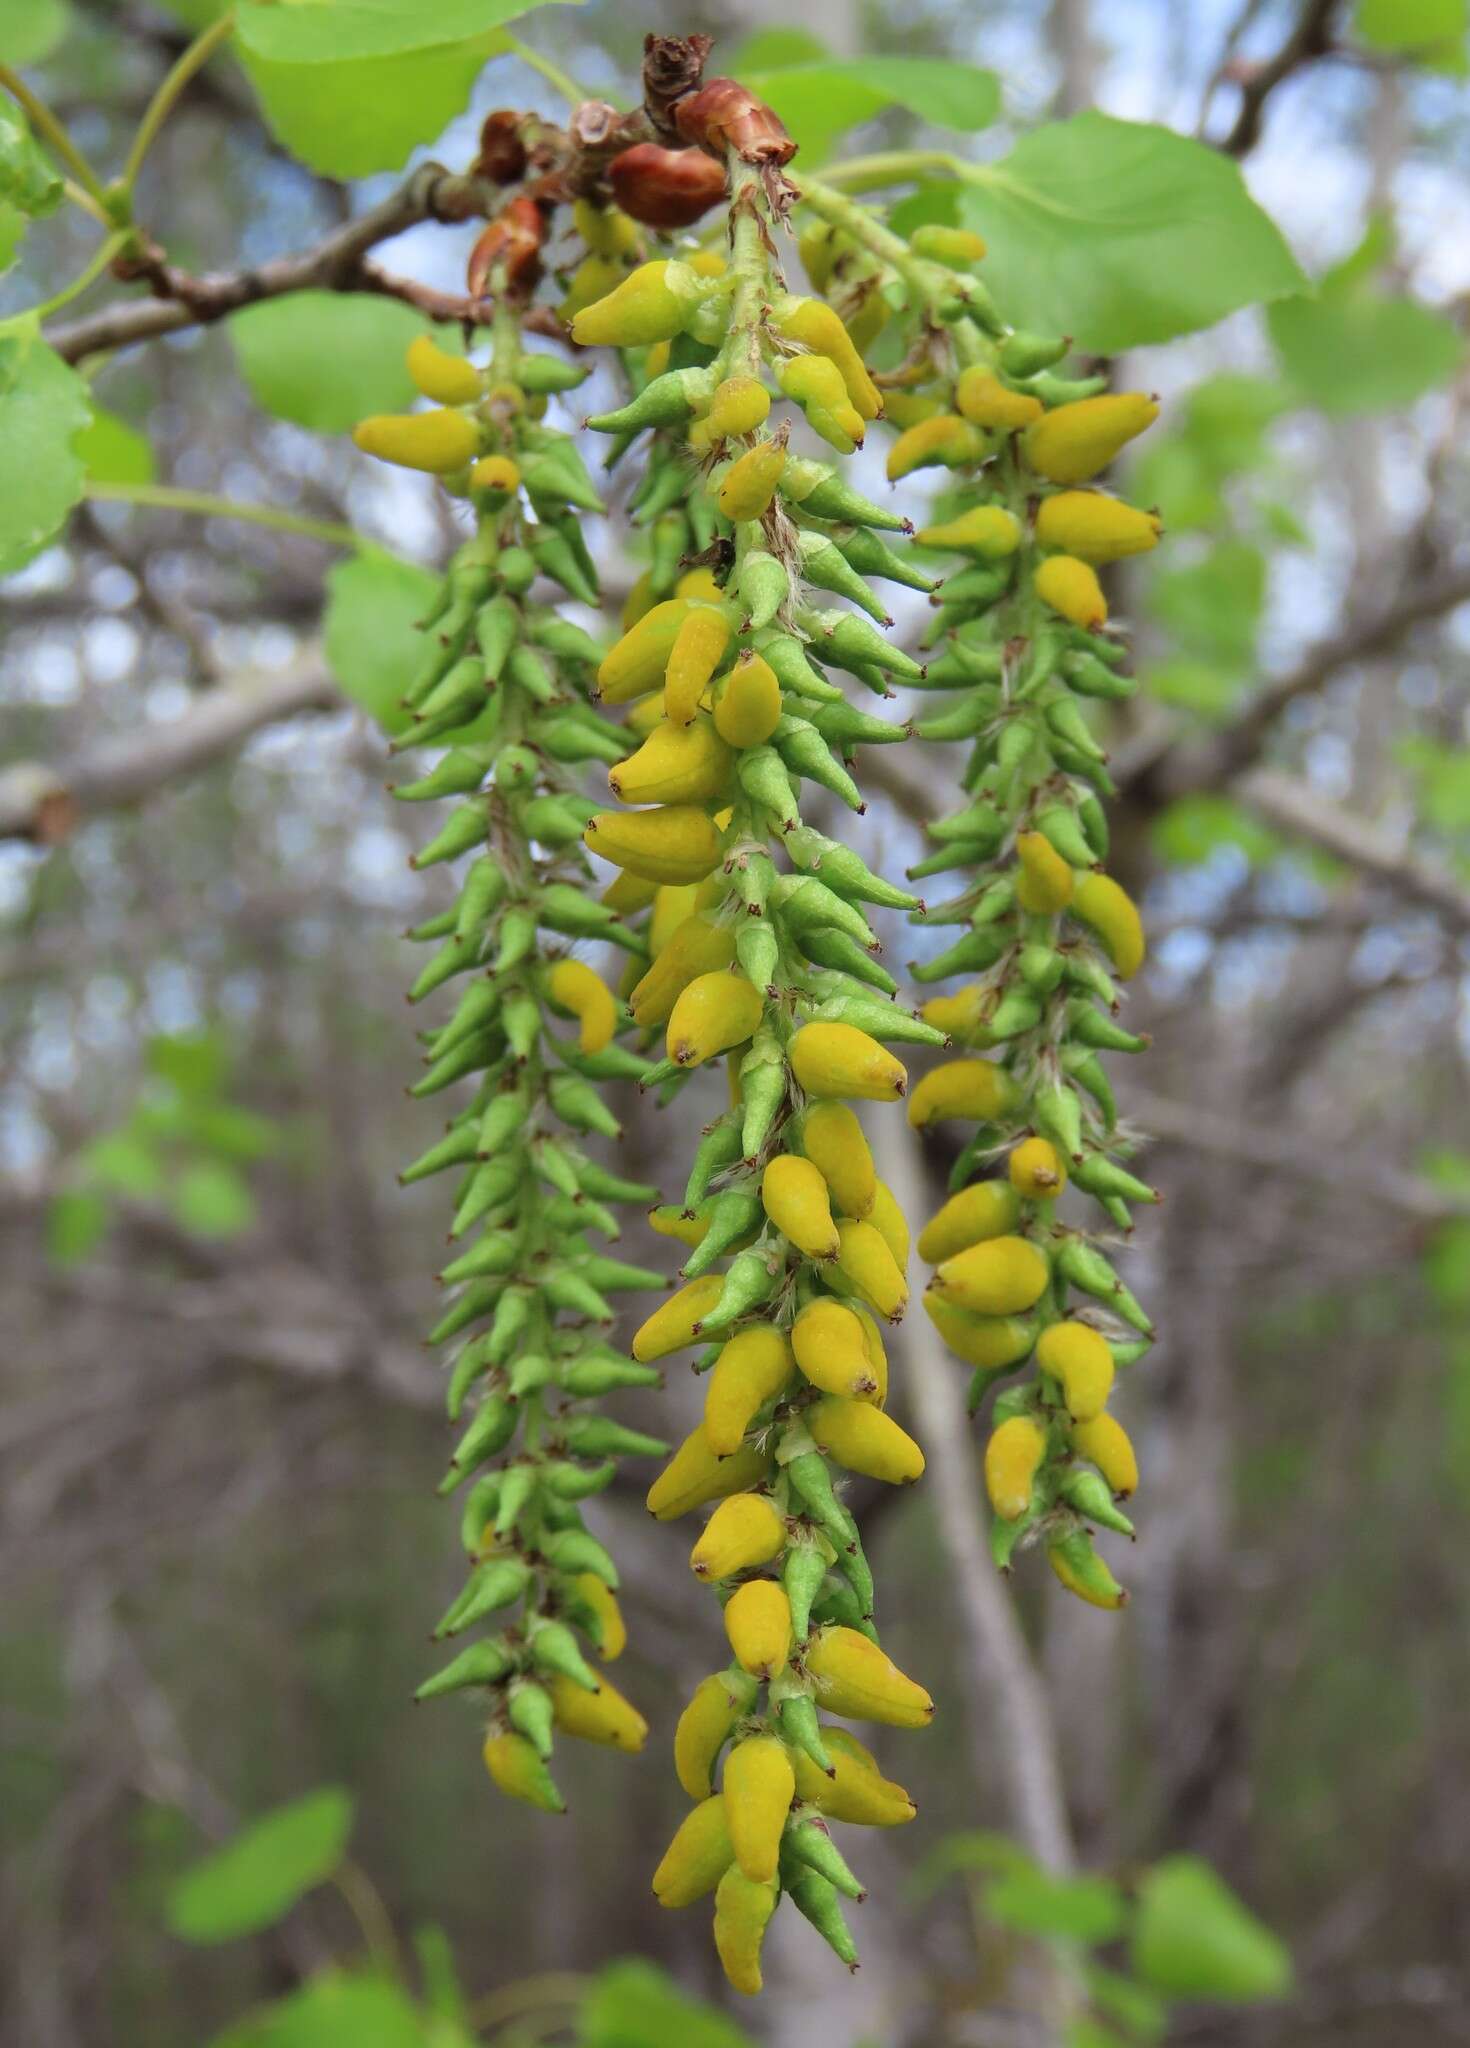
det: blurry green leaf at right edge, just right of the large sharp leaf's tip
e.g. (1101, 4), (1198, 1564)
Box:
(1265, 291), (1466, 414)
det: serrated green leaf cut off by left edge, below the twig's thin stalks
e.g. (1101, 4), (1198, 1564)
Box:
(0, 334), (92, 575)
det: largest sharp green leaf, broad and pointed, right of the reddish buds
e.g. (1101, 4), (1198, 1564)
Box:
(962, 113), (1306, 354)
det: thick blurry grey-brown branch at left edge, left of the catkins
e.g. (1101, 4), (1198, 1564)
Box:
(0, 662), (342, 846)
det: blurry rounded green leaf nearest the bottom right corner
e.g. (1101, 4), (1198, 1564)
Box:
(1132, 1855), (1292, 2003)
